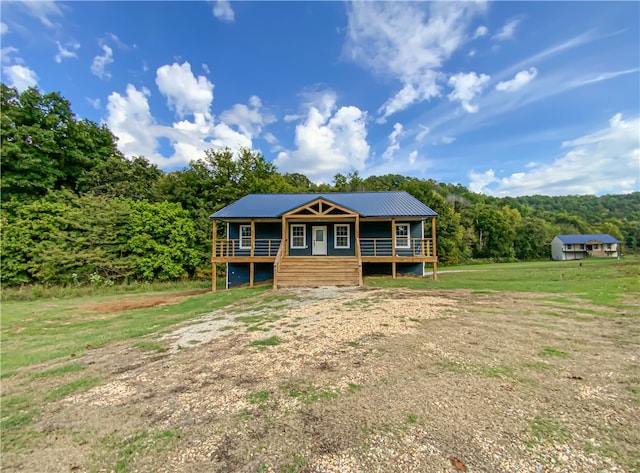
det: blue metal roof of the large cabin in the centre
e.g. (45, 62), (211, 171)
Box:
(210, 191), (438, 219)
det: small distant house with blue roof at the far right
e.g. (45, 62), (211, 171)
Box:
(551, 233), (620, 261)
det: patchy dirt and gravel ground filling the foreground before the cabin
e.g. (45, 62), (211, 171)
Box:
(2, 288), (640, 472)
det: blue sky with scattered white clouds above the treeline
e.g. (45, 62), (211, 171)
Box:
(0, 1), (640, 196)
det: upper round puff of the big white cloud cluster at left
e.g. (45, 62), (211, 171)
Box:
(156, 62), (213, 117)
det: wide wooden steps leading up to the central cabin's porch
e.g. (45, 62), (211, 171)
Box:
(274, 256), (361, 287)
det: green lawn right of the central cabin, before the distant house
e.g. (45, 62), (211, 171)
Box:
(366, 257), (640, 308)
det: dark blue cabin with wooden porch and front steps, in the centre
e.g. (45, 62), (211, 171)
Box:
(210, 192), (438, 290)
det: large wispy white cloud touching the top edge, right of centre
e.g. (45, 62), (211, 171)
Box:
(344, 2), (486, 122)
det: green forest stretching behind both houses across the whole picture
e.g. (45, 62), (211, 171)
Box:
(0, 84), (640, 286)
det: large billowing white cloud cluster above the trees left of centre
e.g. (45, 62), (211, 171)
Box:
(107, 63), (277, 168)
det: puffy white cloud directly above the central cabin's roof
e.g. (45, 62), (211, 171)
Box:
(274, 92), (369, 182)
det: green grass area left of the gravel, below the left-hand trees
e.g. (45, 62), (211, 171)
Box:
(0, 287), (268, 378)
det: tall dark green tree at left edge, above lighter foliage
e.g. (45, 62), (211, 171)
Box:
(0, 84), (119, 201)
